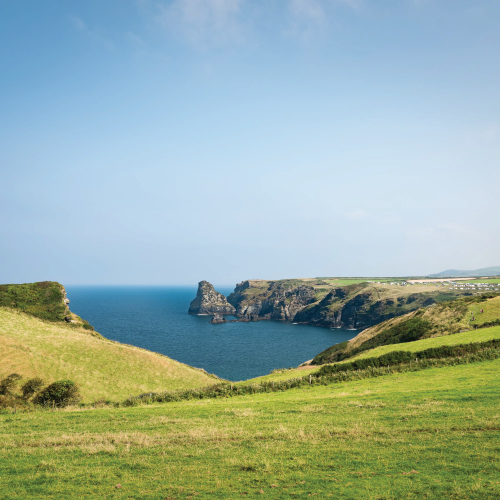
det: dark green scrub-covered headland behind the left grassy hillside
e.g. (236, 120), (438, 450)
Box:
(0, 281), (93, 330)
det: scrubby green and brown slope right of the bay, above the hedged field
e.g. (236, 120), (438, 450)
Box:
(312, 294), (500, 365)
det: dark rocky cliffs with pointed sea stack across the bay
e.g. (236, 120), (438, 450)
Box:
(190, 278), (468, 330)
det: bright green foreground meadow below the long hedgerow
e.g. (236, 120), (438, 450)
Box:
(0, 360), (500, 499)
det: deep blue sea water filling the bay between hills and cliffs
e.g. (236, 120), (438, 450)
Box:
(66, 286), (357, 381)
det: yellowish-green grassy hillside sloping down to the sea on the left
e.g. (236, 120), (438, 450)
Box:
(0, 307), (219, 402)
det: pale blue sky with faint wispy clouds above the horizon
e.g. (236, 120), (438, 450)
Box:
(0, 0), (500, 285)
